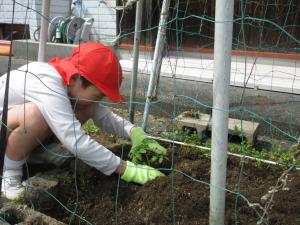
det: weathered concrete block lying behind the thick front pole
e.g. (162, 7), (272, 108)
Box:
(176, 111), (259, 142)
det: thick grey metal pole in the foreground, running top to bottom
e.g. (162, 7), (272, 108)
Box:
(209, 0), (234, 225)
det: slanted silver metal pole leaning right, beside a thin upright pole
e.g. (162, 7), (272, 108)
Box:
(142, 0), (170, 130)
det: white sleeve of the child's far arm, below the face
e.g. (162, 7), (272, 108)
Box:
(92, 104), (134, 139)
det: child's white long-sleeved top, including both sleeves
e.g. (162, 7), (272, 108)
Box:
(0, 62), (133, 175)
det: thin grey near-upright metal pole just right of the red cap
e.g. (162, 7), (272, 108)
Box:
(129, 0), (144, 123)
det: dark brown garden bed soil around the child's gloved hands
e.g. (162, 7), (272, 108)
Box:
(26, 141), (300, 225)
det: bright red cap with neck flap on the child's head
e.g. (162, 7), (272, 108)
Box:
(48, 42), (125, 102)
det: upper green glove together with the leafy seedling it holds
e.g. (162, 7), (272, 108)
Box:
(129, 127), (167, 165)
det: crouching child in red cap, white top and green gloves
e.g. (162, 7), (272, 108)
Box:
(0, 42), (166, 199)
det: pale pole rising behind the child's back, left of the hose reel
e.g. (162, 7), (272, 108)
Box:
(38, 0), (50, 62)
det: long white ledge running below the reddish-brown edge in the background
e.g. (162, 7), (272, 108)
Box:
(121, 57), (300, 94)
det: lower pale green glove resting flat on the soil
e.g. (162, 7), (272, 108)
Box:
(121, 161), (164, 184)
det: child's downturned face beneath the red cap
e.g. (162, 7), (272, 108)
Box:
(68, 79), (104, 105)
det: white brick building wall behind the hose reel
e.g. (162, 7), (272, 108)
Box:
(0, 0), (117, 41)
